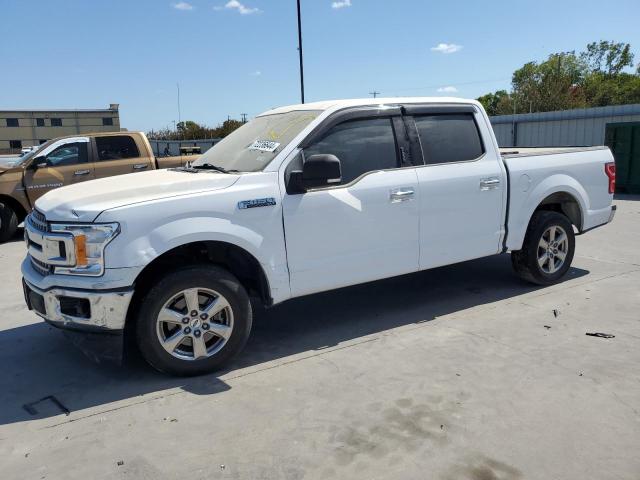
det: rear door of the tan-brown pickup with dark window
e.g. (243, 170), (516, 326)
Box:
(93, 135), (154, 178)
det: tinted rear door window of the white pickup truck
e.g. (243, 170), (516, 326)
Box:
(414, 113), (484, 164)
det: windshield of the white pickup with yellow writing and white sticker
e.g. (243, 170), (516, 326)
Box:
(192, 110), (321, 172)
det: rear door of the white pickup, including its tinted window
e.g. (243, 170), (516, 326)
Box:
(406, 105), (506, 269)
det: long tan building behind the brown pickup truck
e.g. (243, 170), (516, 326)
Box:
(0, 103), (120, 153)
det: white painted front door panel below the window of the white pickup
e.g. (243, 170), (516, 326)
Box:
(282, 168), (420, 296)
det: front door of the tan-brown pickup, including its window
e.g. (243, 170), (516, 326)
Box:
(25, 137), (95, 205)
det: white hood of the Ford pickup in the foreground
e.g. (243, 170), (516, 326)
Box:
(36, 170), (239, 222)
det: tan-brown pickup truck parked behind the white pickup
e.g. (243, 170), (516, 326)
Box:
(0, 132), (197, 242)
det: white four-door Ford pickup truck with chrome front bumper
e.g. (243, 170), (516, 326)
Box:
(22, 98), (615, 375)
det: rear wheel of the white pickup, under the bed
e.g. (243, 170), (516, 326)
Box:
(511, 211), (576, 285)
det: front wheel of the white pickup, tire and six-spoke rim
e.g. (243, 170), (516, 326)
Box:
(136, 265), (253, 376)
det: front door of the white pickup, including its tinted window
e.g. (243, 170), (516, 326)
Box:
(283, 116), (419, 296)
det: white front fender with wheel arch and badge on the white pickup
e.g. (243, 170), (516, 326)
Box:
(96, 170), (291, 302)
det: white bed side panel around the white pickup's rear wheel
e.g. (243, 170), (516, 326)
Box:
(504, 148), (613, 250)
